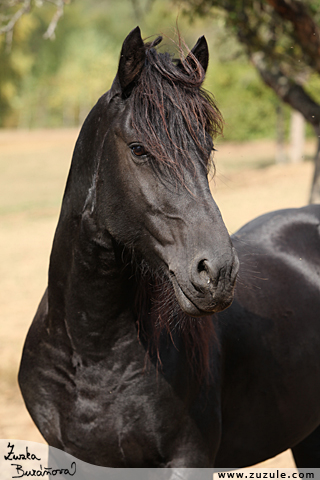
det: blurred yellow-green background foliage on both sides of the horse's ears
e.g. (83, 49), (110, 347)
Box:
(0, 0), (294, 141)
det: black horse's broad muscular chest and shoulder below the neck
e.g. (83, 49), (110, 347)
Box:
(21, 306), (216, 467)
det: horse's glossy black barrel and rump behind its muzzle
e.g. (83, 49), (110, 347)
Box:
(216, 205), (320, 467)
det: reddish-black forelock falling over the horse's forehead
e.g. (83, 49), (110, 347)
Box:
(130, 37), (223, 180)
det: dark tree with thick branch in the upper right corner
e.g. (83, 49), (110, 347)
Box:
(180, 0), (320, 202)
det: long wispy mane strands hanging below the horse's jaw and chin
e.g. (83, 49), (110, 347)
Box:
(134, 263), (217, 383)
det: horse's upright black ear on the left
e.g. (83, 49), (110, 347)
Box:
(118, 27), (145, 92)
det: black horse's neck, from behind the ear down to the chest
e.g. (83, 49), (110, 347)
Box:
(48, 94), (136, 354)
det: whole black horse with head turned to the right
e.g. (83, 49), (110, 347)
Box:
(19, 27), (320, 467)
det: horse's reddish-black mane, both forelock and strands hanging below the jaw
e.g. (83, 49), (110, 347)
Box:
(129, 37), (223, 382)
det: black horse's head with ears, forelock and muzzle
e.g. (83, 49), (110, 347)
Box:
(58, 27), (239, 316)
